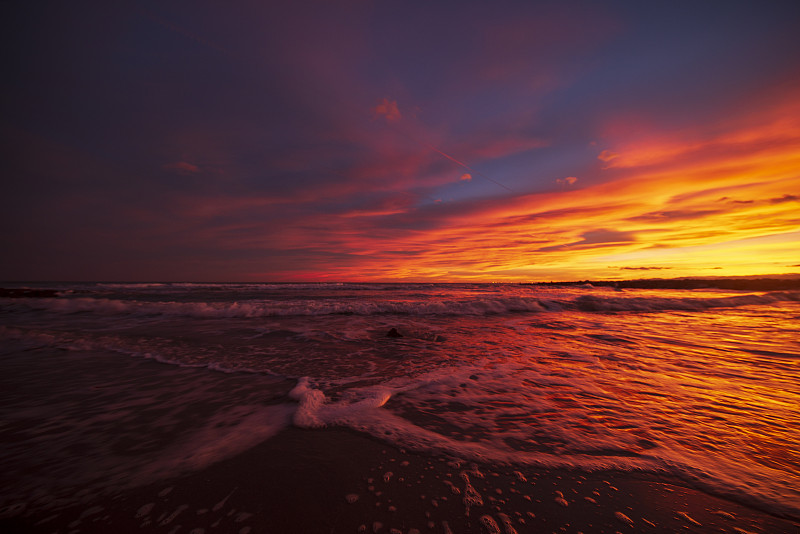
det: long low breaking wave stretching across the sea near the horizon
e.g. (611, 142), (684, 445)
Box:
(3, 292), (800, 318)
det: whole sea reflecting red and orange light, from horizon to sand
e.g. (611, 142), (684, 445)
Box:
(0, 283), (800, 517)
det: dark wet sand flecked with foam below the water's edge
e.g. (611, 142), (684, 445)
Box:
(0, 428), (800, 534)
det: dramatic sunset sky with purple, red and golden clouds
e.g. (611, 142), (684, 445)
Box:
(0, 0), (800, 282)
